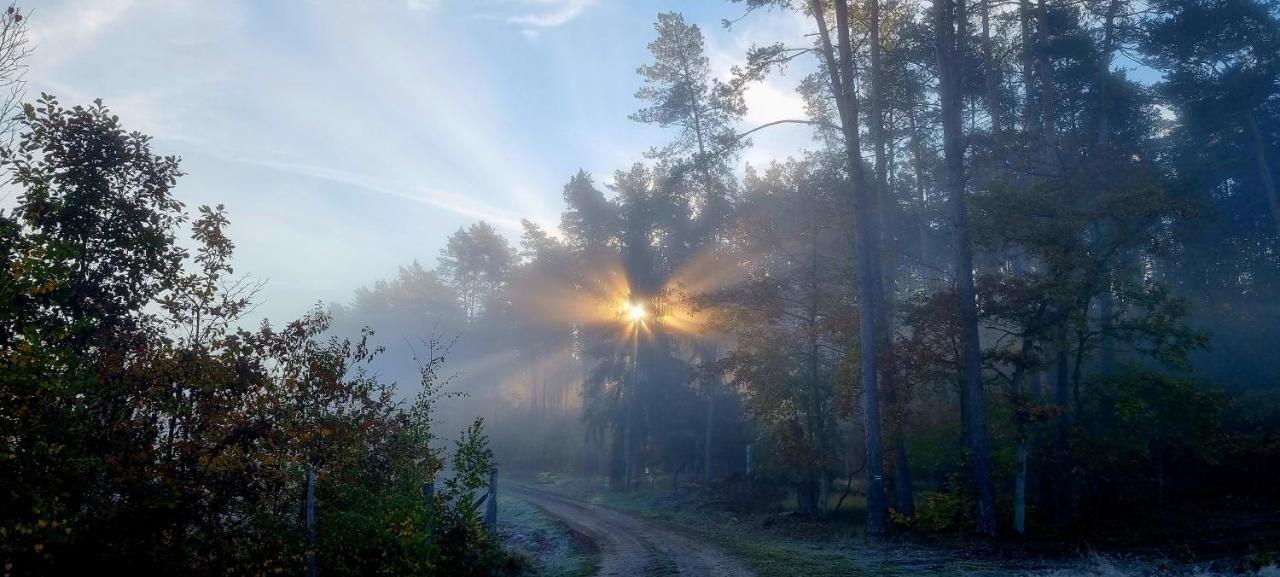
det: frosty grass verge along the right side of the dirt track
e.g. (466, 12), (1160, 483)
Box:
(506, 476), (1280, 577)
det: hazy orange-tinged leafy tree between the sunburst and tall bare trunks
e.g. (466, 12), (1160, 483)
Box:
(707, 157), (860, 513)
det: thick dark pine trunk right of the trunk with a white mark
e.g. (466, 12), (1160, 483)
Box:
(933, 0), (997, 536)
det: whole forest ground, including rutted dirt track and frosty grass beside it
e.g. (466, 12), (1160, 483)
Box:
(499, 476), (1280, 577)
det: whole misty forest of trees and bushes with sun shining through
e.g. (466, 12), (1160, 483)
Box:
(0, 0), (1280, 576)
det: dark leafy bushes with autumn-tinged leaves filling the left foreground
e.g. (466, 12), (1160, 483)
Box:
(0, 96), (513, 574)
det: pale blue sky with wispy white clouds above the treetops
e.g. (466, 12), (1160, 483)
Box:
(17, 0), (812, 324)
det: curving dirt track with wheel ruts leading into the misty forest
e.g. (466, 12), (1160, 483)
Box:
(506, 484), (753, 577)
